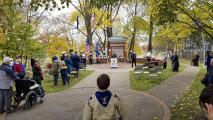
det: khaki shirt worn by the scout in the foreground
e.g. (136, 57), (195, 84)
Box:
(83, 95), (124, 120)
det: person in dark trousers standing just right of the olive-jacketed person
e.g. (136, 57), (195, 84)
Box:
(60, 61), (70, 85)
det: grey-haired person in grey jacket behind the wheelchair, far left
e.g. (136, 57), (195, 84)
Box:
(0, 57), (19, 114)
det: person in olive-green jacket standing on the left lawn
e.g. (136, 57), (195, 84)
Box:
(51, 56), (60, 86)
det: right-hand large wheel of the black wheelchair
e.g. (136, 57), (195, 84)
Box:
(25, 91), (37, 109)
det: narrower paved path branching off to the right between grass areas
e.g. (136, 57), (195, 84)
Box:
(147, 65), (199, 107)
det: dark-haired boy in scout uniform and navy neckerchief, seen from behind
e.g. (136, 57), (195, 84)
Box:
(83, 74), (124, 120)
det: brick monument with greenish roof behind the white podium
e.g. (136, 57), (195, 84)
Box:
(108, 36), (127, 59)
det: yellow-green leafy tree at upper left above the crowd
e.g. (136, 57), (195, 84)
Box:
(0, 0), (43, 57)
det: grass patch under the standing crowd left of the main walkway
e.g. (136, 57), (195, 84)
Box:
(42, 70), (93, 93)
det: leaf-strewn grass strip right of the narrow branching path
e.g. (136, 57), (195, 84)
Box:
(171, 66), (206, 120)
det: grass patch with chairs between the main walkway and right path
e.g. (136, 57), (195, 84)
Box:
(130, 63), (184, 91)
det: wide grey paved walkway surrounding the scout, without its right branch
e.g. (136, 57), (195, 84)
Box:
(6, 65), (169, 120)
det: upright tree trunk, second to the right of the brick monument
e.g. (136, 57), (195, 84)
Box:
(148, 15), (154, 53)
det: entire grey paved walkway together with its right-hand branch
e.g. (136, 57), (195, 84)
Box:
(3, 64), (199, 120)
